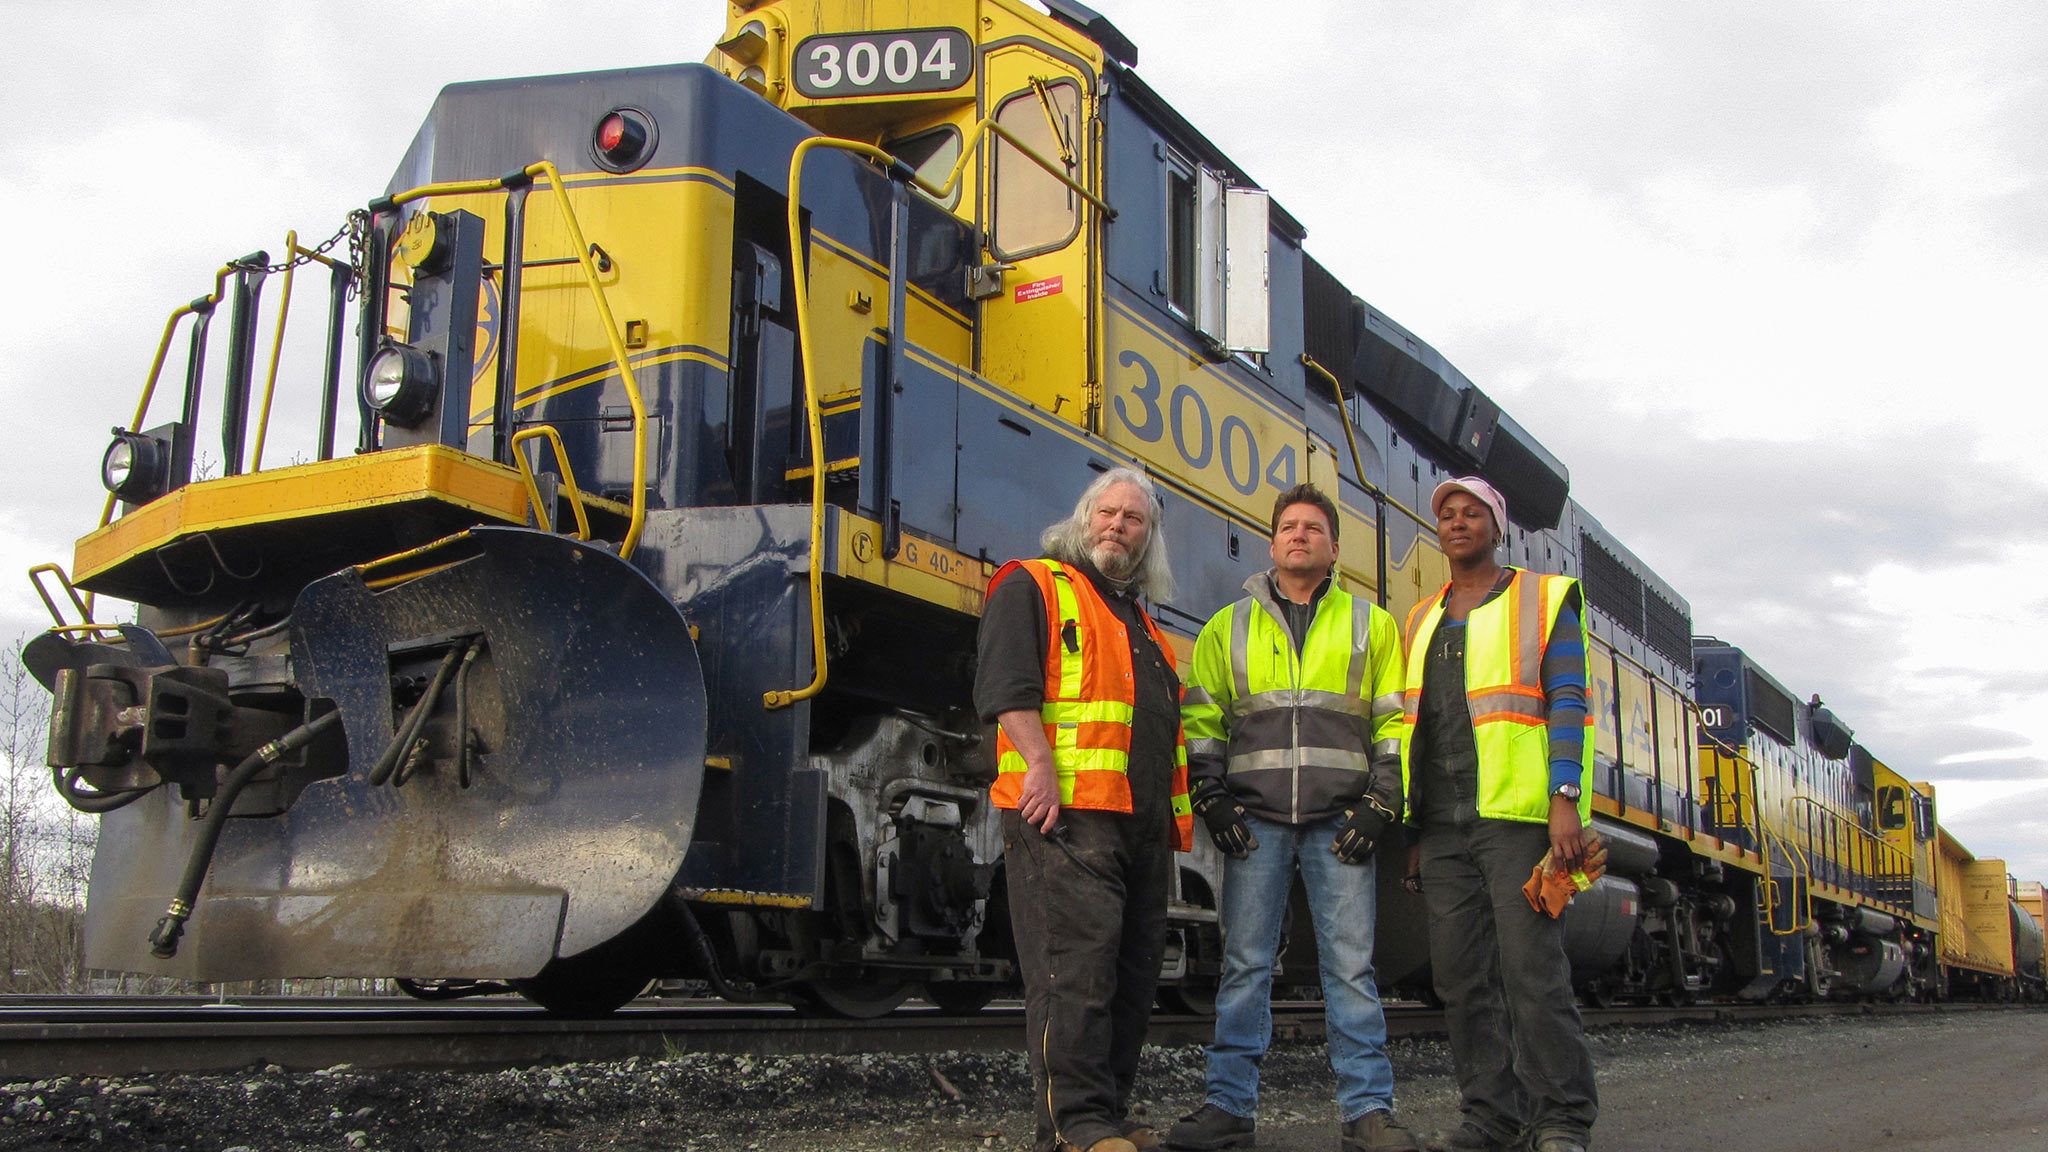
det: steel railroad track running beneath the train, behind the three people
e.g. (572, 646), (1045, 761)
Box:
(0, 998), (1968, 1082)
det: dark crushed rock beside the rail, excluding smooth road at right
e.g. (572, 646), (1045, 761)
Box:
(0, 1019), (1966, 1152)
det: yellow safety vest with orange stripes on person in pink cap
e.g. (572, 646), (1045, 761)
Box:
(1401, 570), (1593, 824)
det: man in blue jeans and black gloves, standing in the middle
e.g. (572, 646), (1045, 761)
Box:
(1167, 484), (1415, 1152)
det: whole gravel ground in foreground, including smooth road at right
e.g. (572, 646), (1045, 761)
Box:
(0, 1009), (2048, 1152)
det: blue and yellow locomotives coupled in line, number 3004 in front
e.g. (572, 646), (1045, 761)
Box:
(27, 0), (2039, 1015)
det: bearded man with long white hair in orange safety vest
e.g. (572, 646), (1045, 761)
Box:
(975, 467), (1194, 1152)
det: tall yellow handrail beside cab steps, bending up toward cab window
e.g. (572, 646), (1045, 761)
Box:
(762, 117), (1116, 707)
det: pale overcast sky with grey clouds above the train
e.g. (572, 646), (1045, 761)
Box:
(0, 0), (2048, 879)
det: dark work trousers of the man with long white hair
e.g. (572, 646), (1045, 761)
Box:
(1004, 804), (1174, 1152)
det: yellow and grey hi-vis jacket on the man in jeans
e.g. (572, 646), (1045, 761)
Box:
(1180, 572), (1407, 824)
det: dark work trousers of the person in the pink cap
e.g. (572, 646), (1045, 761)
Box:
(1421, 804), (1599, 1144)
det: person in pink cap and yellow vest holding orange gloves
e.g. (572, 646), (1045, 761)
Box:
(1401, 476), (1599, 1152)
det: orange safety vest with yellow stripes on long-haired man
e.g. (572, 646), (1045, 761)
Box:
(989, 560), (1194, 853)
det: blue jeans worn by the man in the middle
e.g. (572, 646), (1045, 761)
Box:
(1208, 803), (1395, 1121)
